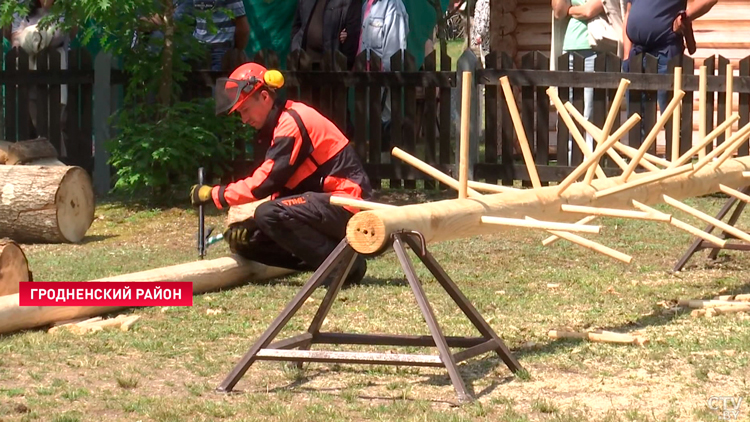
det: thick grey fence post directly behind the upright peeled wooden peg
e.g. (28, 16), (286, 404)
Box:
(453, 50), (481, 179)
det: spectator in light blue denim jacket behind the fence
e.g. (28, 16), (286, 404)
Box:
(357, 0), (409, 162)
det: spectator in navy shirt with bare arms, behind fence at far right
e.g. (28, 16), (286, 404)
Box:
(623, 0), (718, 112)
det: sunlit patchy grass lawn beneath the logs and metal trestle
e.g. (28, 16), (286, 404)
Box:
(0, 193), (750, 422)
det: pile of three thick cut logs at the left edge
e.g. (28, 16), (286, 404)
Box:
(0, 138), (94, 296)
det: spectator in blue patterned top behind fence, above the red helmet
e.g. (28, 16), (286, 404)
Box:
(182, 0), (250, 71)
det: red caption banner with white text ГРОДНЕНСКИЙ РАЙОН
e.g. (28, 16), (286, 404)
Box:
(18, 281), (193, 306)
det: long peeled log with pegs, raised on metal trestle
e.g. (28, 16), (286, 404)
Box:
(346, 157), (750, 254)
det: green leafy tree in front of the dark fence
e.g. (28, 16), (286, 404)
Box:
(0, 0), (253, 193)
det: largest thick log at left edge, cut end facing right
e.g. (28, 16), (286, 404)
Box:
(0, 166), (95, 243)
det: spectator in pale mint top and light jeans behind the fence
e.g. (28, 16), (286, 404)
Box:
(552, 0), (617, 159)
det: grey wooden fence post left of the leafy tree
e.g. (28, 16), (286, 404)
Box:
(94, 52), (112, 195)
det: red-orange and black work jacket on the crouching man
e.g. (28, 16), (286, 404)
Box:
(211, 100), (372, 213)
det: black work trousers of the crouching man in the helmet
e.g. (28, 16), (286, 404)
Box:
(233, 192), (353, 271)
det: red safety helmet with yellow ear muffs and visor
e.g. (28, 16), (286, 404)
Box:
(215, 63), (284, 114)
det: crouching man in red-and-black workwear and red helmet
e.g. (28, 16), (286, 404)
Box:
(190, 63), (372, 284)
